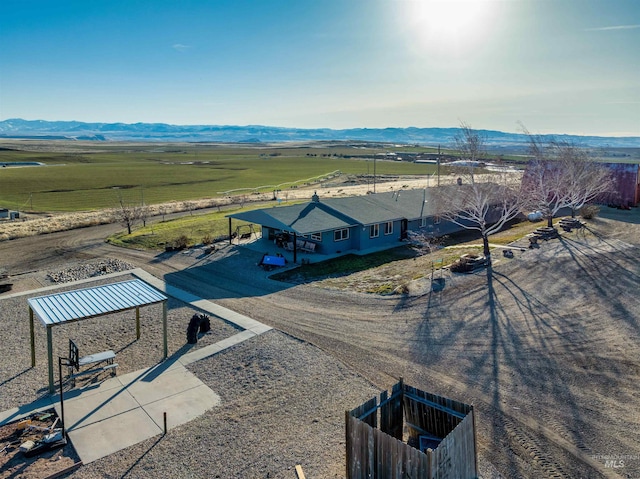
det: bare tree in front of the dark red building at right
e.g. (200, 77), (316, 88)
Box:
(523, 130), (613, 228)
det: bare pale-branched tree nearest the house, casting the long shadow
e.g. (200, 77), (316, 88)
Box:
(435, 123), (526, 267)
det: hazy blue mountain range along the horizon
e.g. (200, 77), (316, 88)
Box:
(0, 118), (640, 148)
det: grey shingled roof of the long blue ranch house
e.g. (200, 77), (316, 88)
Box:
(227, 189), (444, 238)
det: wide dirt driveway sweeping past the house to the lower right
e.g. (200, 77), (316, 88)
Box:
(0, 210), (640, 478)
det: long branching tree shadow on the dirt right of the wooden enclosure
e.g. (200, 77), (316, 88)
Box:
(408, 265), (608, 476)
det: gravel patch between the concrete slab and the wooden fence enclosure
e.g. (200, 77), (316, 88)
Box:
(77, 330), (378, 478)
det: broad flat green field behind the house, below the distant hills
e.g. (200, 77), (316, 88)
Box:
(0, 142), (444, 212)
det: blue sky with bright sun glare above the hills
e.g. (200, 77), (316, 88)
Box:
(0, 0), (640, 136)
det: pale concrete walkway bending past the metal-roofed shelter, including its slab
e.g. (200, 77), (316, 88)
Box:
(0, 269), (272, 464)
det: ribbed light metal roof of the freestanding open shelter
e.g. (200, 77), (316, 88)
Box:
(27, 279), (167, 325)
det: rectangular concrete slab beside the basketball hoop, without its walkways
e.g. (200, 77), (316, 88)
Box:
(55, 362), (220, 464)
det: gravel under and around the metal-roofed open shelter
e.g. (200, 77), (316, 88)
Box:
(0, 274), (239, 410)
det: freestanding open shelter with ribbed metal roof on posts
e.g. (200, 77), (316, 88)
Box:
(27, 279), (168, 394)
